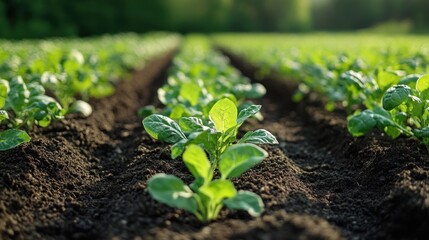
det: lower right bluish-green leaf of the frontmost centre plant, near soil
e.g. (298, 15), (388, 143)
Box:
(223, 191), (264, 217)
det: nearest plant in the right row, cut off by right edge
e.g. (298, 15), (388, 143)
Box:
(348, 75), (429, 150)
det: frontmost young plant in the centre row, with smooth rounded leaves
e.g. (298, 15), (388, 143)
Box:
(148, 144), (267, 222)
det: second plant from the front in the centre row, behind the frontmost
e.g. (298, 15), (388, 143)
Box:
(143, 98), (278, 163)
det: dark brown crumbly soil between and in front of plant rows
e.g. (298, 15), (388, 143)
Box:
(0, 49), (429, 239)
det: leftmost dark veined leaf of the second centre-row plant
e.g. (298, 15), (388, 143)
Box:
(143, 114), (186, 143)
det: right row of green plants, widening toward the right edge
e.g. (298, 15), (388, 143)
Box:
(215, 34), (429, 150)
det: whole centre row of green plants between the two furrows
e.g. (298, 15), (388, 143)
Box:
(140, 36), (278, 222)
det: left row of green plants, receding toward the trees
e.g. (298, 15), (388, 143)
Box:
(0, 33), (180, 151)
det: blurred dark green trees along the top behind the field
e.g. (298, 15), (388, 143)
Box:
(0, 0), (429, 38)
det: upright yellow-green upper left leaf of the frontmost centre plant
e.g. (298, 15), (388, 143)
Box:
(183, 144), (210, 181)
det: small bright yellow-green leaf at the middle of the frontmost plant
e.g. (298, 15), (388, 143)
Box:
(199, 179), (237, 204)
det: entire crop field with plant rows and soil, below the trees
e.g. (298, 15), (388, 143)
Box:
(0, 33), (429, 239)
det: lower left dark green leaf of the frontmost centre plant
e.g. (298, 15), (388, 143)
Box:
(148, 173), (198, 213)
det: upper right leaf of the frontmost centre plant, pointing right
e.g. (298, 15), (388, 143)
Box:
(219, 143), (268, 179)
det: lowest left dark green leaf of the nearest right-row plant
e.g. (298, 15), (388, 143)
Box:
(347, 110), (377, 137)
